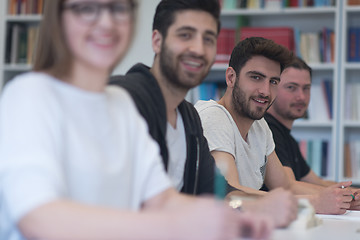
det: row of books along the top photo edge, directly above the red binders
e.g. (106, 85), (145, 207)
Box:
(220, 0), (336, 9)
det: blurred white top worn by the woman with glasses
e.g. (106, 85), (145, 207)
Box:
(0, 72), (171, 240)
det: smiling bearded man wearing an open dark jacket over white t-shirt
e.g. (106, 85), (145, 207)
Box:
(110, 0), (297, 226)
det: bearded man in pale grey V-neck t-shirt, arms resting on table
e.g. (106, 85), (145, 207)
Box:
(195, 37), (351, 214)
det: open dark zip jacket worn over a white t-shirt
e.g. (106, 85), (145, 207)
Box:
(111, 64), (217, 195)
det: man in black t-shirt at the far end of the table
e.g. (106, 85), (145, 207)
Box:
(264, 58), (360, 209)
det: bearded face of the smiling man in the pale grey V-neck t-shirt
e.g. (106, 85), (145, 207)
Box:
(232, 56), (280, 120)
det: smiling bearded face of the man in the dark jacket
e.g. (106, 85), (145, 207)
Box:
(154, 10), (217, 90)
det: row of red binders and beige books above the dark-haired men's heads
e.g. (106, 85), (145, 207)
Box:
(215, 27), (334, 64)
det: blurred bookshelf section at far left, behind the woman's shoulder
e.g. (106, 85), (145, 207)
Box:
(0, 0), (43, 90)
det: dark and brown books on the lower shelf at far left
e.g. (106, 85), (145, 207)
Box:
(5, 23), (39, 64)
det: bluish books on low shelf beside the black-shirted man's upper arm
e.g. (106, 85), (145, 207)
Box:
(298, 139), (333, 177)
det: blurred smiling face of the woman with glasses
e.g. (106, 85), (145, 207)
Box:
(62, 0), (132, 71)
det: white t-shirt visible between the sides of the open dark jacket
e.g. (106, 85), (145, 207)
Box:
(166, 110), (186, 191)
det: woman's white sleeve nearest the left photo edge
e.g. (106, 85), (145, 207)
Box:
(0, 79), (63, 222)
